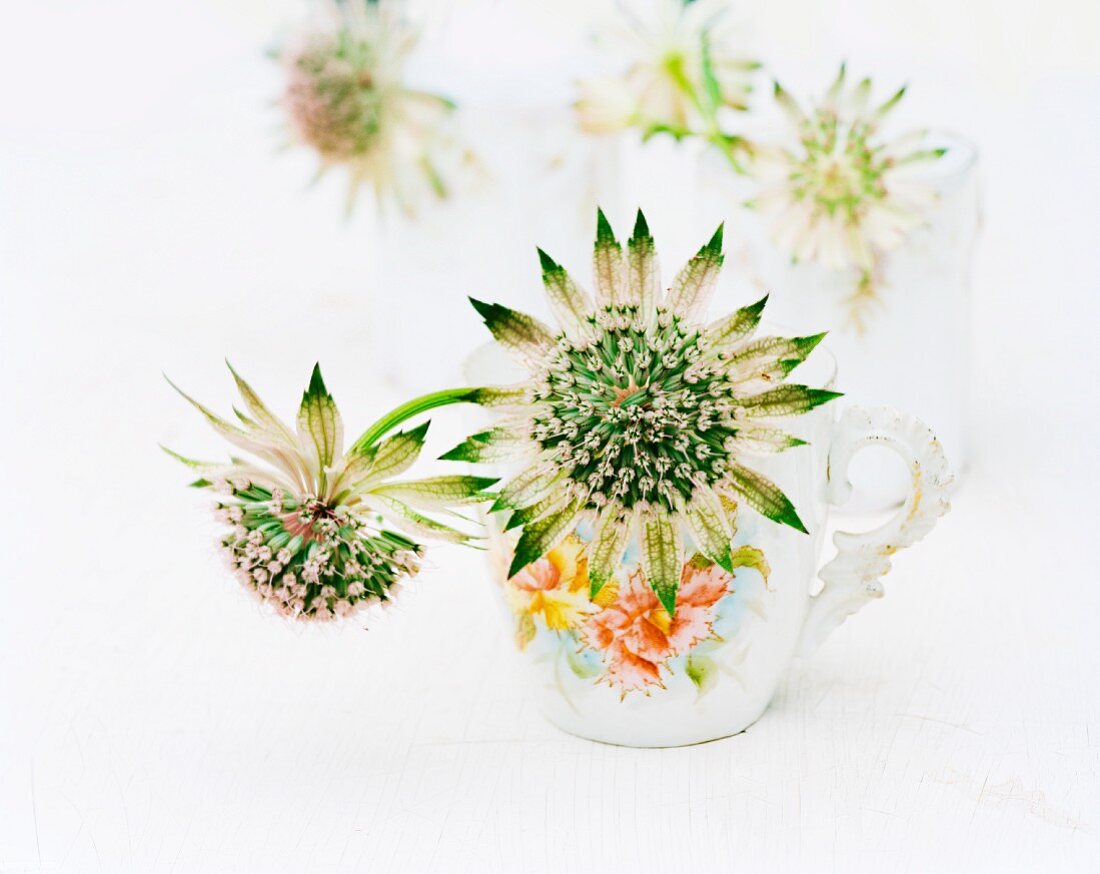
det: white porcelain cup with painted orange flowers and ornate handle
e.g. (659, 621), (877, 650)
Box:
(468, 347), (952, 746)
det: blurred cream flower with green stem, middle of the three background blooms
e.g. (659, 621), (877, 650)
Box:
(576, 0), (760, 170)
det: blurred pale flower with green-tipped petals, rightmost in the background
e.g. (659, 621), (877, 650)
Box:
(750, 65), (946, 327)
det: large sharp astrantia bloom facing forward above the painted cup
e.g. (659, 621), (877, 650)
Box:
(443, 212), (836, 615)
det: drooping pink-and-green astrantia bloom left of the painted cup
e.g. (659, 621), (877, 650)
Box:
(169, 367), (495, 620)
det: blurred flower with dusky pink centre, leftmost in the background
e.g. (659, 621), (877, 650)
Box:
(279, 0), (454, 210)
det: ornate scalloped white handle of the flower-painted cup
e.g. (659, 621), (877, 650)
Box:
(799, 407), (953, 656)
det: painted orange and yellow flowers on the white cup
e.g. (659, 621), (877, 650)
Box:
(504, 534), (770, 698)
